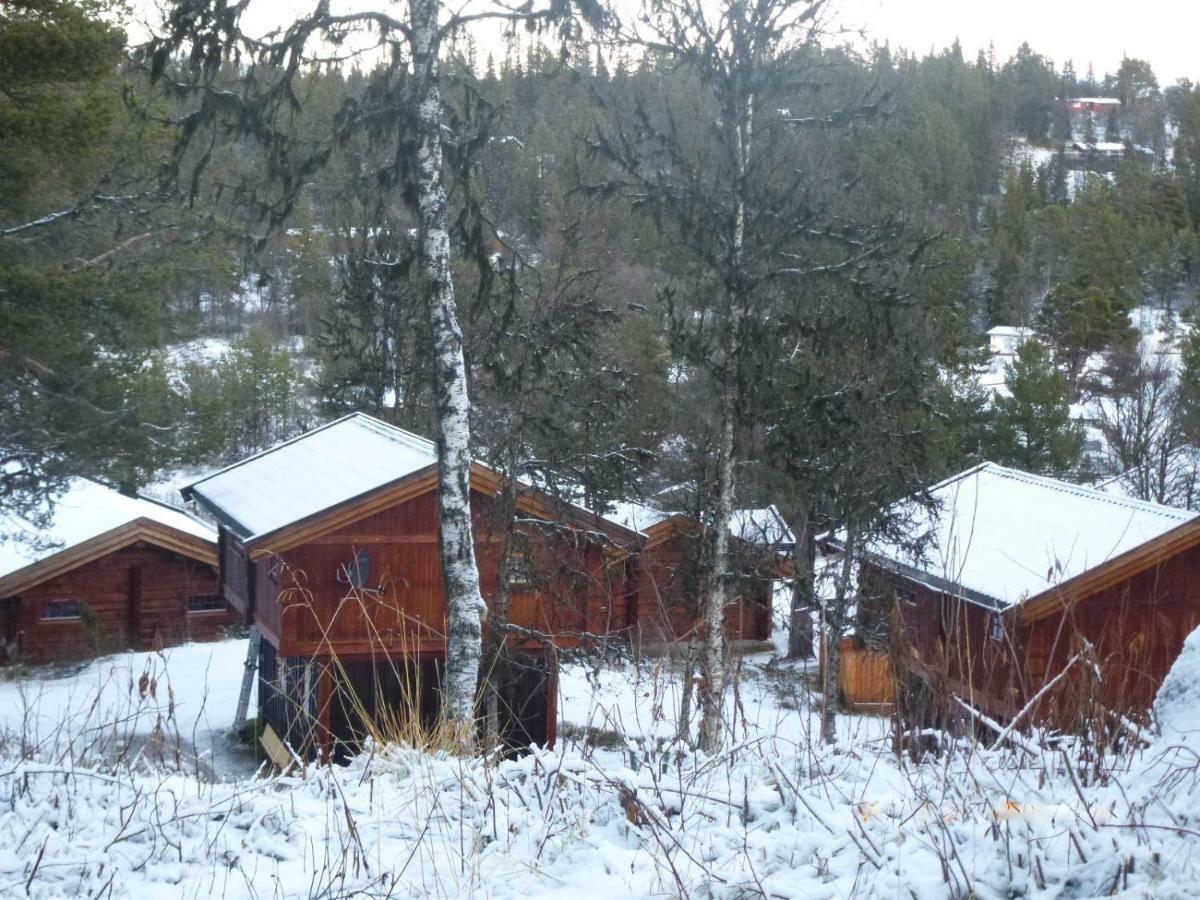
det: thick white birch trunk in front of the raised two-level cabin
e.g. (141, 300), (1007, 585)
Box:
(409, 0), (487, 744)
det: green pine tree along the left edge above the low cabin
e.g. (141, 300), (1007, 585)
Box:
(0, 0), (190, 520)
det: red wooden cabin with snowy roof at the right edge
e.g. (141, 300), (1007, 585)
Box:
(840, 463), (1200, 730)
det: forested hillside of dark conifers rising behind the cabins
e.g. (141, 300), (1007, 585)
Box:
(0, 4), (1200, 515)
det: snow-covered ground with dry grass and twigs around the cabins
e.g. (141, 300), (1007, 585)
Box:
(0, 636), (1200, 900)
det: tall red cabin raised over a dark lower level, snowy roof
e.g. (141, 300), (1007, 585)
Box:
(184, 414), (637, 756)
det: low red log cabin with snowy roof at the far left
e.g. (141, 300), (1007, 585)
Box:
(0, 479), (228, 665)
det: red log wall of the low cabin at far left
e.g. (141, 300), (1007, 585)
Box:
(0, 544), (229, 665)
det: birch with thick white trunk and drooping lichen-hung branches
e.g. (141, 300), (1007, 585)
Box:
(148, 0), (600, 746)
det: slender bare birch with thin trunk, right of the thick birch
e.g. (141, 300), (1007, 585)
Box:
(593, 0), (876, 751)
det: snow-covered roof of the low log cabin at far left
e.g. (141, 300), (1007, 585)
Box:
(0, 478), (217, 578)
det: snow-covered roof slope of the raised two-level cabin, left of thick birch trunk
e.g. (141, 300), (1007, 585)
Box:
(184, 413), (438, 540)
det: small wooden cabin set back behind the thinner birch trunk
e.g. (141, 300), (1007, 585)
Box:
(608, 502), (793, 648)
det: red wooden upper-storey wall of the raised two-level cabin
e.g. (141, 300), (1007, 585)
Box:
(235, 492), (628, 659)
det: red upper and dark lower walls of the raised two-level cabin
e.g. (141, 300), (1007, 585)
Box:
(221, 482), (632, 757)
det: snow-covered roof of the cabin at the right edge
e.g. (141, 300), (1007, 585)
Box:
(869, 462), (1198, 608)
